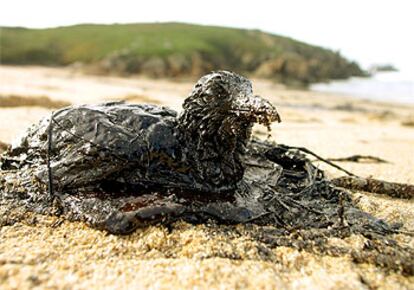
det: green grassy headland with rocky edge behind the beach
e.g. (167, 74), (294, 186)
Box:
(0, 23), (363, 84)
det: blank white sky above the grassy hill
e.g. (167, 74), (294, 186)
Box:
(0, 0), (414, 73)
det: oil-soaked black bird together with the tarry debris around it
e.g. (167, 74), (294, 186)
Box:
(0, 72), (414, 275)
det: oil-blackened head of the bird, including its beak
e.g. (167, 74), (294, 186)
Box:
(182, 71), (281, 138)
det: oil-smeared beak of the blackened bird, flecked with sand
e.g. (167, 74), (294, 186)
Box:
(231, 96), (281, 126)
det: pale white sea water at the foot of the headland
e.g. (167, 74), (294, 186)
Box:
(310, 71), (414, 104)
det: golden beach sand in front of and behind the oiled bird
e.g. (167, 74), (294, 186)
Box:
(0, 66), (414, 289)
